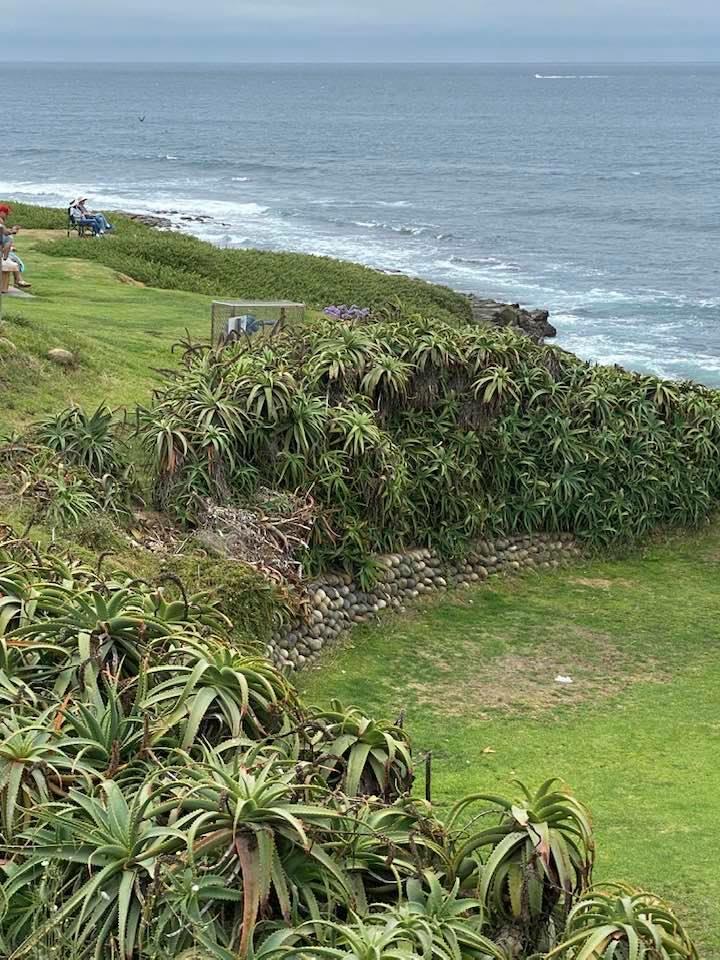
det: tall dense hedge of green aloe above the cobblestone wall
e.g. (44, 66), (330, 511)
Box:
(135, 316), (720, 579)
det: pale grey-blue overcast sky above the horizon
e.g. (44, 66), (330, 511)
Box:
(9, 0), (720, 62)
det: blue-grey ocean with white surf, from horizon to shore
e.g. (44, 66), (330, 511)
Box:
(0, 64), (720, 386)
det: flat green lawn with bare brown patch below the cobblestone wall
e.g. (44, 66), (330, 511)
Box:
(300, 526), (720, 957)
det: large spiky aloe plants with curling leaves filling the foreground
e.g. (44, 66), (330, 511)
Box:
(0, 535), (696, 960)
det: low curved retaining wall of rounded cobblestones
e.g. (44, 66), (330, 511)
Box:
(267, 533), (581, 670)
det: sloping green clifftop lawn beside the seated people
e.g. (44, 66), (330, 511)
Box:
(0, 230), (210, 428)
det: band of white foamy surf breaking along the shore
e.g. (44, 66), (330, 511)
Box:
(0, 171), (720, 382)
